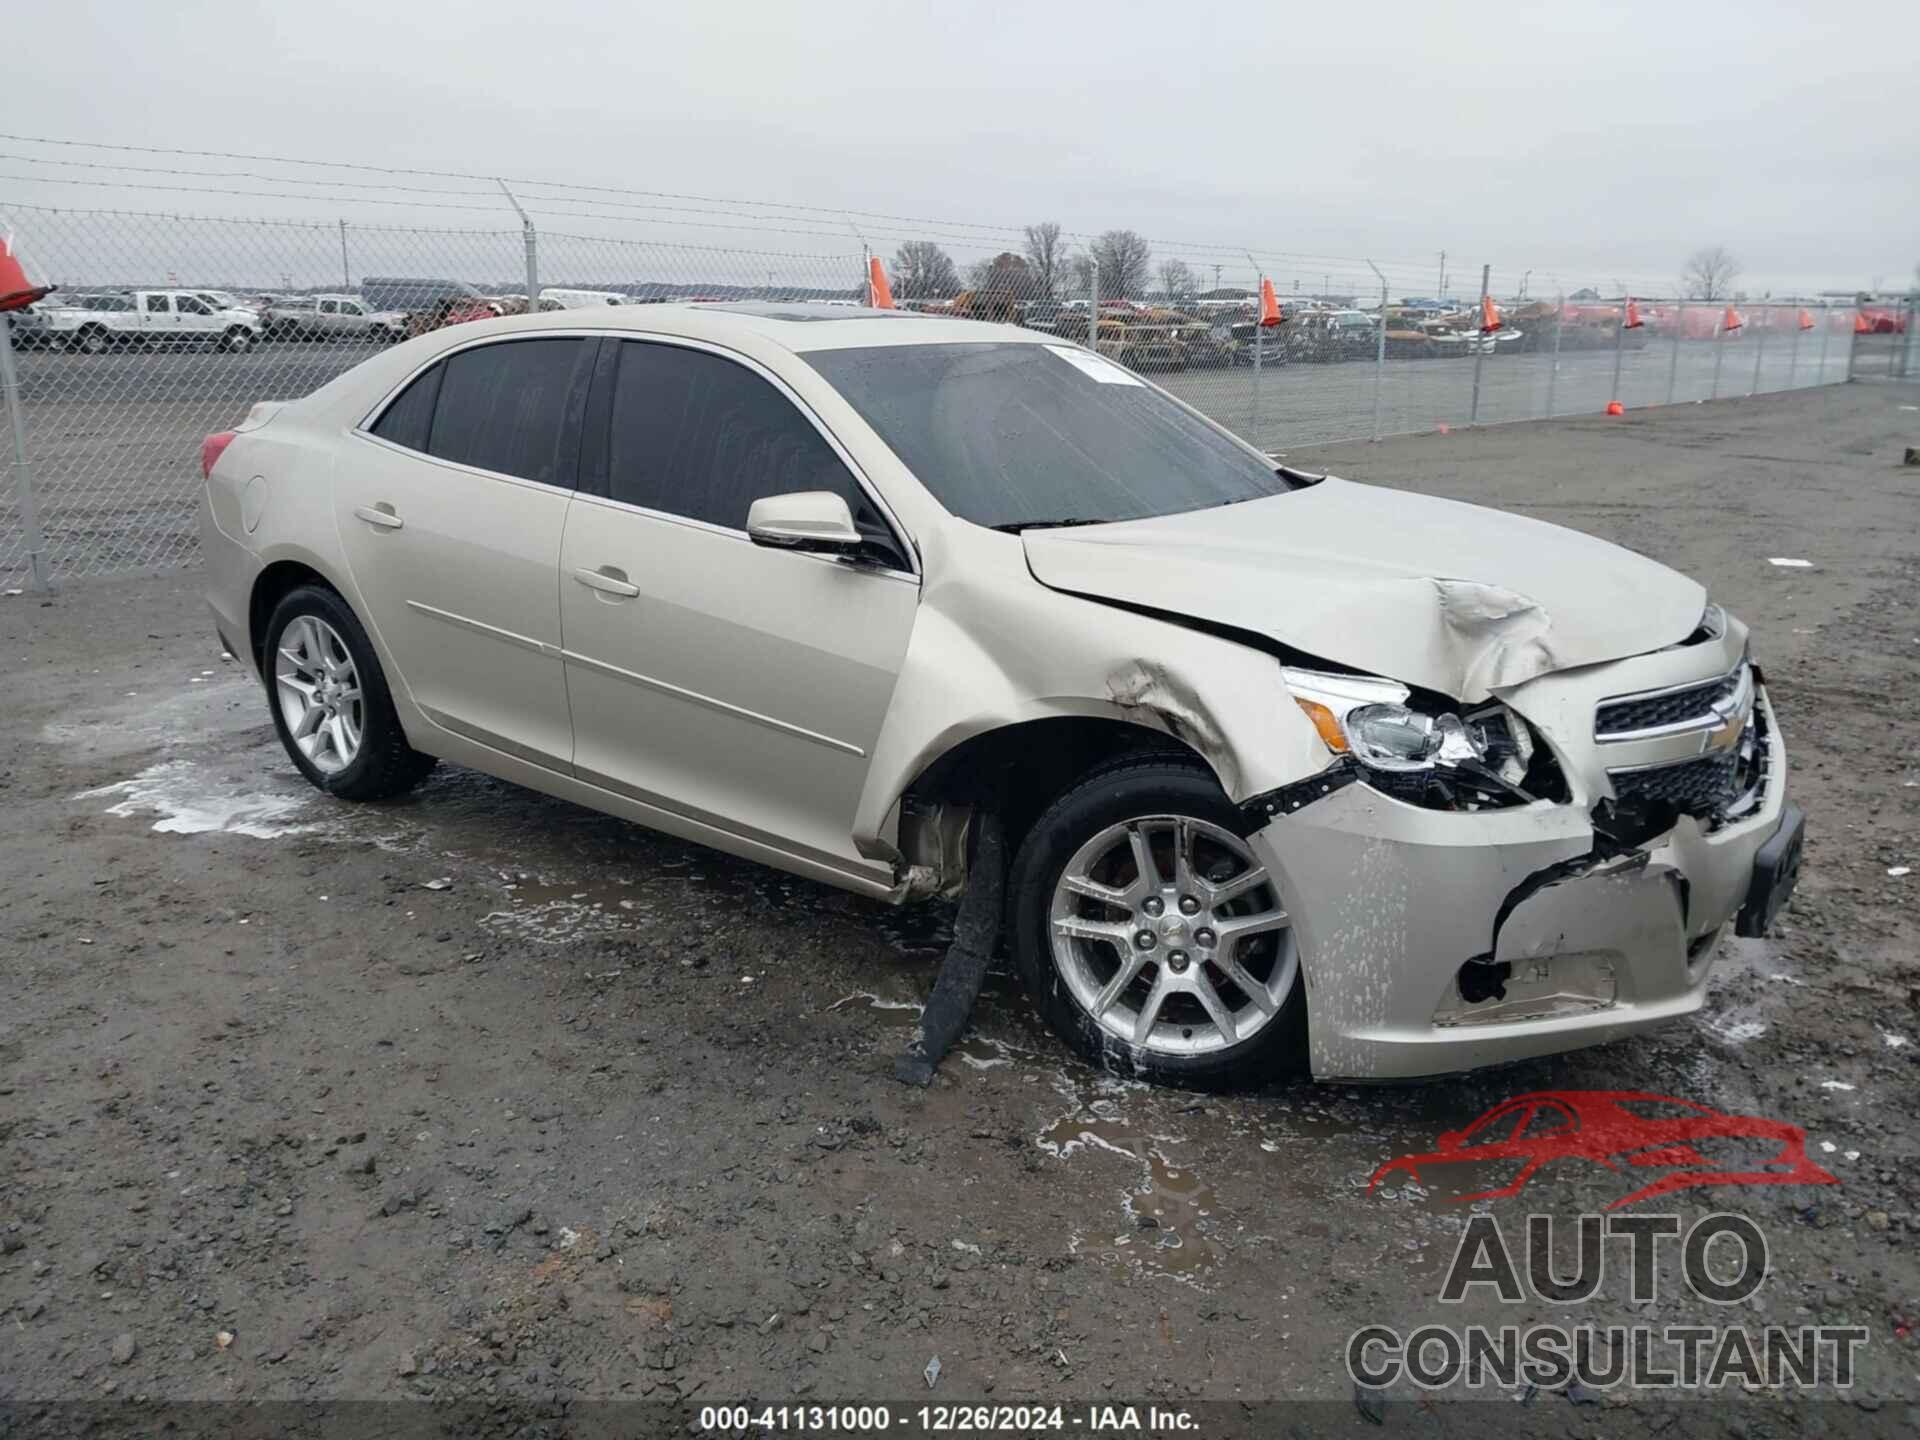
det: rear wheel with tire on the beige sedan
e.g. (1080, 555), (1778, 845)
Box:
(261, 586), (434, 801)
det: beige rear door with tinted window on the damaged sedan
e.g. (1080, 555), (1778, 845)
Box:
(334, 336), (599, 772)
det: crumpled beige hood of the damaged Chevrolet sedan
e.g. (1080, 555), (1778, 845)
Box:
(1021, 476), (1707, 703)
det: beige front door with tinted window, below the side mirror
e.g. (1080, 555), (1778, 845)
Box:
(561, 340), (920, 881)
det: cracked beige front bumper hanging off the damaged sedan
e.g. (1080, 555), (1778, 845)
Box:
(1250, 697), (1797, 1081)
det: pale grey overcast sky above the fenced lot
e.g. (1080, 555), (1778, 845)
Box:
(0, 0), (1920, 294)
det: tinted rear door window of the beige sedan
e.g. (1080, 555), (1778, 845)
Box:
(428, 340), (591, 486)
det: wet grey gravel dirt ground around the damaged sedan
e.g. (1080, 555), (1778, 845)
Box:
(0, 384), (1920, 1434)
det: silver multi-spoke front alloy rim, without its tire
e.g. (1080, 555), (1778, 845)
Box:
(1048, 814), (1300, 1056)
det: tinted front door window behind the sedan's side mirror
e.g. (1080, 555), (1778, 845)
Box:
(607, 342), (885, 536)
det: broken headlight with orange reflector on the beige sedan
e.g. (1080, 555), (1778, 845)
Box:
(1283, 666), (1536, 808)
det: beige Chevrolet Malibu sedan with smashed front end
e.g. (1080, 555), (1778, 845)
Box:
(200, 303), (1803, 1087)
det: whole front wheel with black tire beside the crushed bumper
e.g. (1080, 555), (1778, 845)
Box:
(1008, 756), (1306, 1089)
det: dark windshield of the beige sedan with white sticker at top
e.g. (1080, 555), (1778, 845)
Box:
(804, 344), (1288, 530)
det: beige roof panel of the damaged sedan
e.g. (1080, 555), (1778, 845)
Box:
(416, 301), (1060, 355)
